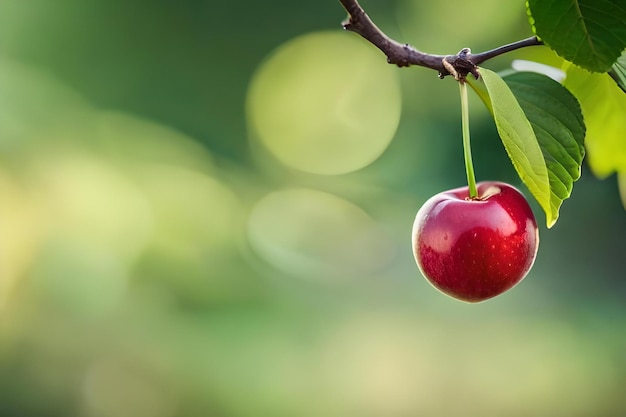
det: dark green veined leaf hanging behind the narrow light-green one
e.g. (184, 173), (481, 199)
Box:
(504, 72), (585, 226)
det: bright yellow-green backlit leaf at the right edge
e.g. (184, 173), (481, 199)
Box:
(563, 64), (626, 178)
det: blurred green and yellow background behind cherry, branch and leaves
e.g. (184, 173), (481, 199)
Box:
(0, 0), (626, 417)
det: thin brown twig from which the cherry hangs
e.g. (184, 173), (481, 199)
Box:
(339, 0), (543, 79)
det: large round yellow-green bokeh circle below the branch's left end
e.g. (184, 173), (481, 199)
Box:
(247, 32), (402, 175)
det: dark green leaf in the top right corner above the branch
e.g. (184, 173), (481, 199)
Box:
(527, 0), (626, 72)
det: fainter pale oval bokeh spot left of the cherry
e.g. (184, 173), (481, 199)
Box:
(248, 188), (395, 283)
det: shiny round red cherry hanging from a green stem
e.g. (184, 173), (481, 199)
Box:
(412, 182), (539, 303)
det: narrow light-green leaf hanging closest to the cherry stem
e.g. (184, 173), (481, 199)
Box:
(470, 68), (558, 227)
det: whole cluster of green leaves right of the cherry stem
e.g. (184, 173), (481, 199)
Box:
(470, 0), (626, 227)
